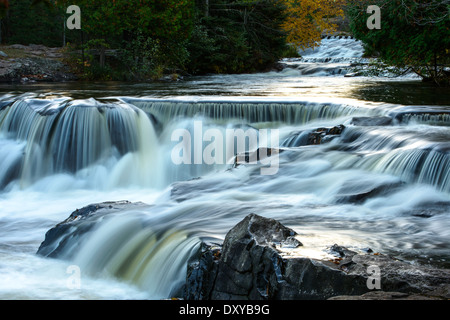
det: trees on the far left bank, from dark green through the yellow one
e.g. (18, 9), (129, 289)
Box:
(0, 0), (345, 79)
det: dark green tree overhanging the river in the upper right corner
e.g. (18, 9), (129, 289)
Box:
(347, 0), (450, 85)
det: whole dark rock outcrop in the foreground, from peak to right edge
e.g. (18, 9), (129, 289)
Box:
(185, 214), (450, 300)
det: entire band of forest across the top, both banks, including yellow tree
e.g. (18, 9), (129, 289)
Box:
(0, 0), (450, 85)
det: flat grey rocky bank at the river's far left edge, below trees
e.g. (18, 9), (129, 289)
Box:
(0, 44), (77, 83)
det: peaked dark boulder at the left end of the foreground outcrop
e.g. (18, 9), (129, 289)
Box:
(186, 214), (302, 300)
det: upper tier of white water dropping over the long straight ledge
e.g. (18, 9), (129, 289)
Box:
(0, 95), (384, 190)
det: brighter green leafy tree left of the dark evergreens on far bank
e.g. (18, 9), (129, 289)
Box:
(63, 0), (194, 77)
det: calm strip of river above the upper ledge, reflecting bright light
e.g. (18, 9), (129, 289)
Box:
(0, 74), (450, 105)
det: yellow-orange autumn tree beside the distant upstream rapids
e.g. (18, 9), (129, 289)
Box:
(282, 0), (345, 49)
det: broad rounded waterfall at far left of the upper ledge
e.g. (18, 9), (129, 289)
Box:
(0, 99), (158, 188)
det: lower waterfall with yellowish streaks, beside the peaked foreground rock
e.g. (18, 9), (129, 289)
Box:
(72, 212), (200, 299)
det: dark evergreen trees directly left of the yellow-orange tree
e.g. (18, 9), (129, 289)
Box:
(188, 0), (286, 73)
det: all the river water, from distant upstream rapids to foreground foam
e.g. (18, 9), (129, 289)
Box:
(0, 39), (450, 299)
